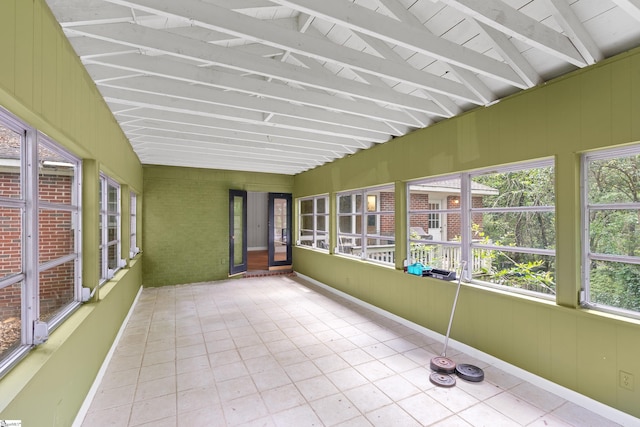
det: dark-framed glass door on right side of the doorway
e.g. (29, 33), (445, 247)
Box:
(269, 193), (291, 269)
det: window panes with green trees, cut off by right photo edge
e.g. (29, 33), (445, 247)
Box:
(582, 146), (640, 317)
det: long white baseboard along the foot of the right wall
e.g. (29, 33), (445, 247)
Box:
(295, 272), (640, 427)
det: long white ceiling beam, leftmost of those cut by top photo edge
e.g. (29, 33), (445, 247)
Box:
(100, 0), (480, 102)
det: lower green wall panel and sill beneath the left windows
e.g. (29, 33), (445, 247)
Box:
(0, 262), (142, 427)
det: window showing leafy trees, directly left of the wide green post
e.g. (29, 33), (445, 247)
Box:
(468, 161), (556, 295)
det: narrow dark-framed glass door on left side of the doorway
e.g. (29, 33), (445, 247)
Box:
(229, 190), (247, 275)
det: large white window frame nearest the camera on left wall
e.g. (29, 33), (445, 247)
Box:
(0, 108), (82, 377)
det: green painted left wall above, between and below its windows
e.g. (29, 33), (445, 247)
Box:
(0, 0), (142, 426)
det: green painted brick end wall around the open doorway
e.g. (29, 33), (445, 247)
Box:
(142, 166), (293, 286)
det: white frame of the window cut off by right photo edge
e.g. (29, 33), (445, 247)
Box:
(580, 145), (640, 319)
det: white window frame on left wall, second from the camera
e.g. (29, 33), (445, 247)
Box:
(100, 173), (126, 285)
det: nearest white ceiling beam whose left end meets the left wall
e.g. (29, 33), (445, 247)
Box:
(67, 24), (444, 114)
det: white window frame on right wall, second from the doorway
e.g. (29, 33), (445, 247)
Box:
(335, 184), (396, 266)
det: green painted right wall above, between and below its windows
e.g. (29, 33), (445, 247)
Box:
(293, 49), (640, 417)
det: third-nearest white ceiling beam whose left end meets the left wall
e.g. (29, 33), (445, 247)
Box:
(99, 76), (400, 134)
